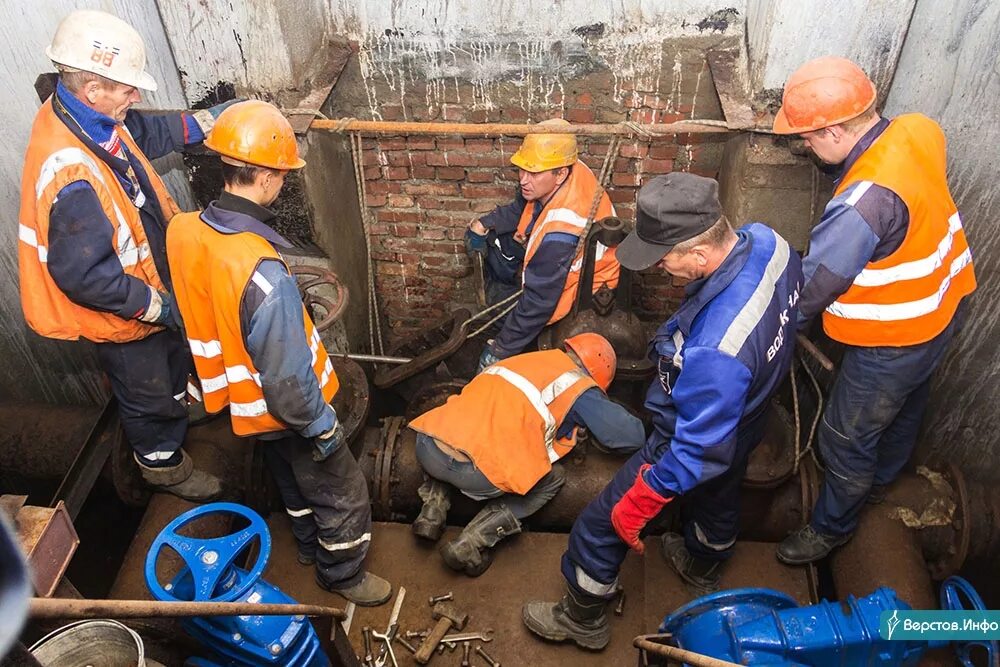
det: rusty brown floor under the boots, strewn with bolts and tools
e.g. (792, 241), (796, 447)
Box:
(264, 514), (809, 667)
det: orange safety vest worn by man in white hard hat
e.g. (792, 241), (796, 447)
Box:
(17, 98), (180, 343)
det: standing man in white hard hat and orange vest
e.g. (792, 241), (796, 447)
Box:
(18, 10), (237, 501)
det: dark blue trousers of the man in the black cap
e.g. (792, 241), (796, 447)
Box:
(562, 410), (768, 598)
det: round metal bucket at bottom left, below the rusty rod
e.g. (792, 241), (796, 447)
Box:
(29, 619), (147, 667)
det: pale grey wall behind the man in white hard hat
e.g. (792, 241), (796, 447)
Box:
(0, 0), (192, 403)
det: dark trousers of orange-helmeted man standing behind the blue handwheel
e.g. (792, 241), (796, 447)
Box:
(264, 435), (372, 588)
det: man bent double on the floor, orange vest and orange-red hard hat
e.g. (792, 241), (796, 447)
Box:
(410, 333), (645, 576)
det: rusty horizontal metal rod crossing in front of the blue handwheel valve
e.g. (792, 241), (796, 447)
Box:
(30, 598), (347, 621)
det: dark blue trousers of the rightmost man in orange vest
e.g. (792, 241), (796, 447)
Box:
(811, 315), (960, 535)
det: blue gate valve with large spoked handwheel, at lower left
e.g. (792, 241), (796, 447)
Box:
(145, 503), (330, 667)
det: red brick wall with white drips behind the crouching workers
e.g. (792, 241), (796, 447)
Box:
(332, 34), (726, 340)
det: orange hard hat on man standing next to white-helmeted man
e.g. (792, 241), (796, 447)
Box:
(199, 100), (306, 171)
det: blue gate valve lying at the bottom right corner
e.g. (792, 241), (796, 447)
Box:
(660, 577), (1000, 667)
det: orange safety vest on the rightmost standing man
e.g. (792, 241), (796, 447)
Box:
(823, 114), (976, 347)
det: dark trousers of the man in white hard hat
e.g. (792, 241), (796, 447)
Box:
(97, 330), (194, 466)
